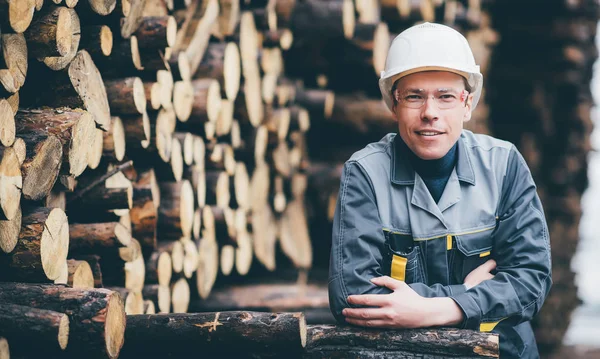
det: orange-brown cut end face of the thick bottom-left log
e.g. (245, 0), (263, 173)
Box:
(104, 292), (127, 358)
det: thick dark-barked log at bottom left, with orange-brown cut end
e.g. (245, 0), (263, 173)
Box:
(0, 283), (126, 358)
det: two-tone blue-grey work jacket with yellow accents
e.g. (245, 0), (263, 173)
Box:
(329, 130), (552, 358)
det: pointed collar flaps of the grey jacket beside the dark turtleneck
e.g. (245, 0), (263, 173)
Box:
(390, 134), (475, 185)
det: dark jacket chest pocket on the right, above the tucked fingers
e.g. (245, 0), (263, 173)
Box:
(453, 227), (495, 283)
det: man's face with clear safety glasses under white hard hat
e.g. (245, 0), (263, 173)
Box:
(394, 71), (473, 160)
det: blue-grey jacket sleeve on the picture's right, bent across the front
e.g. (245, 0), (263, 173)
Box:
(451, 146), (552, 329)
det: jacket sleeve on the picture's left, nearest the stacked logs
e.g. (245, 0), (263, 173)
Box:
(329, 161), (391, 322)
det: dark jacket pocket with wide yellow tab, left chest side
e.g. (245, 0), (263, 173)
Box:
(385, 232), (425, 284)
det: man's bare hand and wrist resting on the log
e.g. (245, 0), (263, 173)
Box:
(342, 276), (463, 328)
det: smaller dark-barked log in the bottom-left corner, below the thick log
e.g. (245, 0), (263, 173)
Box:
(0, 303), (69, 356)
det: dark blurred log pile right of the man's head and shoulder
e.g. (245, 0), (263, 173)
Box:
(488, 1), (600, 354)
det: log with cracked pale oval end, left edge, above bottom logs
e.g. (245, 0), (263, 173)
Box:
(0, 207), (69, 282)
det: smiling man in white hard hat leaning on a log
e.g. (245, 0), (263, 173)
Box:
(329, 23), (552, 358)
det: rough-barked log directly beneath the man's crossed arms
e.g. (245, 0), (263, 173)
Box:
(306, 325), (499, 358)
